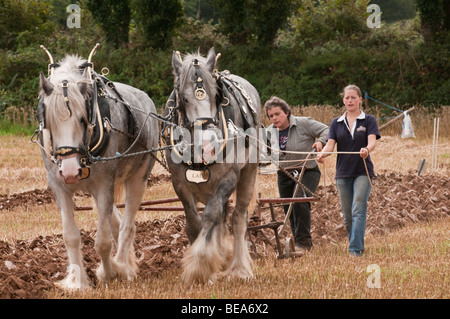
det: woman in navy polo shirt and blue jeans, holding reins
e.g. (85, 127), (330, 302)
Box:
(317, 85), (381, 256)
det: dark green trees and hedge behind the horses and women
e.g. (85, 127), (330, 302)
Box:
(0, 0), (450, 120)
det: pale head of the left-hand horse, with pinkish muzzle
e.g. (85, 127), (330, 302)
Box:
(39, 56), (92, 184)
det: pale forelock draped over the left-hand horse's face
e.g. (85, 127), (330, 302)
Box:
(40, 55), (93, 130)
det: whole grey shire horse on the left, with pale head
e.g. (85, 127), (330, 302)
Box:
(36, 50), (159, 289)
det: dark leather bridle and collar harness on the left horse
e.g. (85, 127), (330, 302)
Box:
(31, 62), (135, 179)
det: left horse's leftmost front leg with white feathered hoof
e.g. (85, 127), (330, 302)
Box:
(54, 188), (89, 290)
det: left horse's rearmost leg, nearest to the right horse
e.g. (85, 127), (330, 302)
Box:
(115, 161), (151, 280)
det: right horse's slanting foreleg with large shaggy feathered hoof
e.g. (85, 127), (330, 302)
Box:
(182, 174), (237, 285)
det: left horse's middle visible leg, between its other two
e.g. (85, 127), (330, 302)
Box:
(93, 182), (126, 282)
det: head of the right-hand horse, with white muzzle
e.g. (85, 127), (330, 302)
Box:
(172, 48), (221, 162)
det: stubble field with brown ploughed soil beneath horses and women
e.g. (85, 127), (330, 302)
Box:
(0, 105), (450, 299)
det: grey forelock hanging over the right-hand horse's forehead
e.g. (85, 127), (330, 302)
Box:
(178, 52), (217, 102)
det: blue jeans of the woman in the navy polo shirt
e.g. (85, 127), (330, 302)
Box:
(336, 175), (371, 256)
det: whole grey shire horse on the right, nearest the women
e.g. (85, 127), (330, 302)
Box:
(163, 48), (261, 285)
